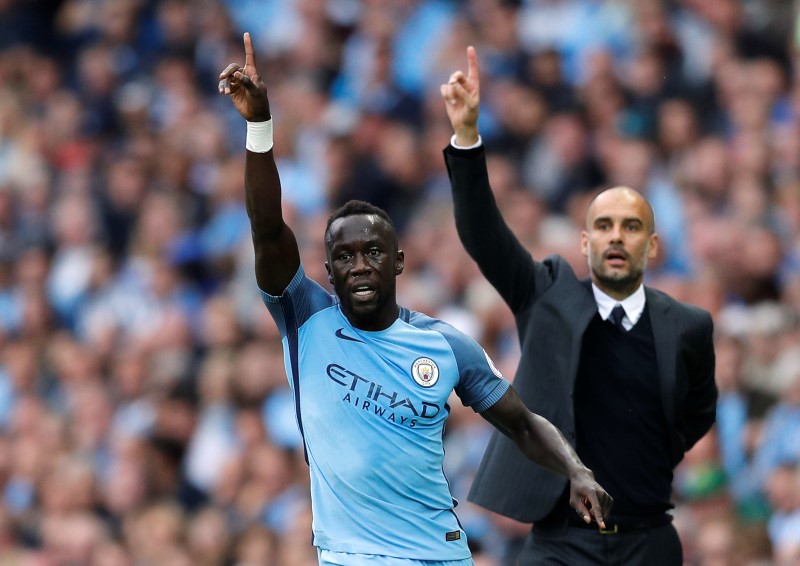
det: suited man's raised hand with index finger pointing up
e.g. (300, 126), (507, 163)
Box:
(439, 46), (481, 146)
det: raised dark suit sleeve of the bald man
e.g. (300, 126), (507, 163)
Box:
(444, 146), (546, 313)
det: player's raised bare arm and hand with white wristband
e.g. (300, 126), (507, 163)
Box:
(219, 33), (300, 295)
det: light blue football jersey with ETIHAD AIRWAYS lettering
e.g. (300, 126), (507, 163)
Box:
(262, 266), (509, 560)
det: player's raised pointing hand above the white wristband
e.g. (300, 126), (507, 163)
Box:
(219, 32), (270, 122)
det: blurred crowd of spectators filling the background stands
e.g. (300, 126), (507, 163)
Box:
(0, 0), (800, 566)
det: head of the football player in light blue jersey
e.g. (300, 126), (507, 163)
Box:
(325, 214), (403, 330)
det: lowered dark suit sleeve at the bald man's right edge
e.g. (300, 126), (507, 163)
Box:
(681, 313), (717, 450)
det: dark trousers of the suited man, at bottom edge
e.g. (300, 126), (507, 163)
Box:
(519, 523), (683, 566)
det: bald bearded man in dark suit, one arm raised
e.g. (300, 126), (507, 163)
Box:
(441, 47), (717, 566)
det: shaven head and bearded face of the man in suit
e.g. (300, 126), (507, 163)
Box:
(581, 187), (658, 299)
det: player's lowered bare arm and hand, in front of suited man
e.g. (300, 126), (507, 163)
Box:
(481, 387), (613, 528)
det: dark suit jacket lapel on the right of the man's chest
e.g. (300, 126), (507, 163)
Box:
(645, 287), (678, 425)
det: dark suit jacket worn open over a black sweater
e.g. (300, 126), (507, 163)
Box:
(445, 147), (717, 522)
